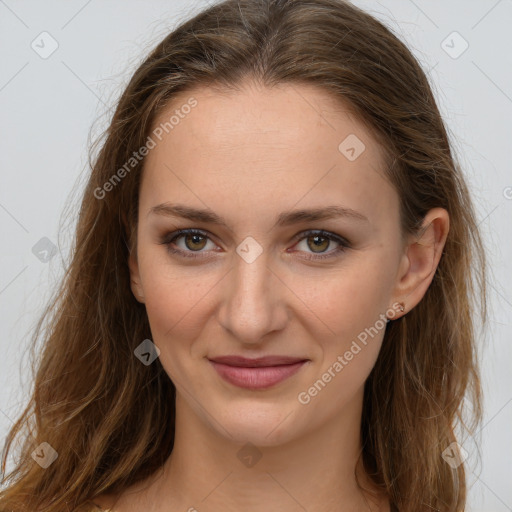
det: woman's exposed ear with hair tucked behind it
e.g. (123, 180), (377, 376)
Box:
(394, 208), (450, 315)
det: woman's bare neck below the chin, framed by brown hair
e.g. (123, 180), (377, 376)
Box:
(143, 389), (389, 512)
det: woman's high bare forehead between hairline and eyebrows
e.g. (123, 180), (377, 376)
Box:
(141, 82), (397, 230)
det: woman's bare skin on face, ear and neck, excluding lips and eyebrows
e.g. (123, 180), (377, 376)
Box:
(95, 81), (449, 512)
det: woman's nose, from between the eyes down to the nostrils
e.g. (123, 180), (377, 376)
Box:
(218, 252), (291, 345)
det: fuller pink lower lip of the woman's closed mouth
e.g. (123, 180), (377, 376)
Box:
(210, 361), (307, 389)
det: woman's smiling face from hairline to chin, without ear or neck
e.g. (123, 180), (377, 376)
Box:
(130, 84), (403, 446)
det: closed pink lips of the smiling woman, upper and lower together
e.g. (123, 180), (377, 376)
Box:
(209, 356), (308, 389)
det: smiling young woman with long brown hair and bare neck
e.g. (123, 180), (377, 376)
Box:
(0, 0), (486, 512)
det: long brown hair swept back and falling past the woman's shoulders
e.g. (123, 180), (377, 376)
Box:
(0, 0), (487, 512)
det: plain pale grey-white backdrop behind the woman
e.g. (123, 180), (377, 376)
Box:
(0, 0), (512, 512)
